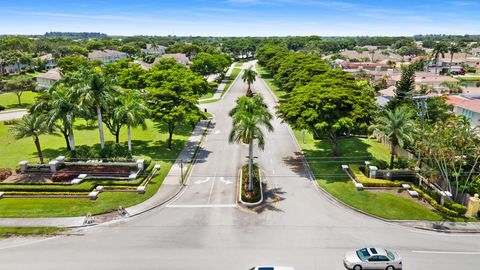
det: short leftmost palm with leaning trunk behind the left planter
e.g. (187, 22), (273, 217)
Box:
(10, 114), (52, 164)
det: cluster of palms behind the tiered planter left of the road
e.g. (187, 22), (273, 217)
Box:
(12, 69), (148, 163)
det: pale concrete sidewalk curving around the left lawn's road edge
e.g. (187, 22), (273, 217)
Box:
(0, 120), (209, 227)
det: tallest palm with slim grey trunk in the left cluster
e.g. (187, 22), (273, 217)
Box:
(75, 69), (116, 149)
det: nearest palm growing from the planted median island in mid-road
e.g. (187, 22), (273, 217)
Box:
(228, 96), (273, 191)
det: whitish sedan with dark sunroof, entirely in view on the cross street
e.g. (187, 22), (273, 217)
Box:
(343, 248), (402, 270)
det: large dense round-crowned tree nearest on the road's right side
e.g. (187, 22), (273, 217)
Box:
(277, 71), (375, 156)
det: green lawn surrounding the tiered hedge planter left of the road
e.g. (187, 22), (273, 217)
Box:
(0, 120), (193, 217)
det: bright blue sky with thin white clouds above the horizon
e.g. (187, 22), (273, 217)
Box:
(0, 0), (480, 36)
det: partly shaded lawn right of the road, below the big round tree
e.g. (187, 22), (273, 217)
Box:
(295, 132), (454, 220)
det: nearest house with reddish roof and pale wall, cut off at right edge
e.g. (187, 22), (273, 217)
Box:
(447, 95), (480, 126)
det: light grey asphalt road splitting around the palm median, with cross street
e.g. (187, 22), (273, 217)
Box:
(0, 61), (480, 270)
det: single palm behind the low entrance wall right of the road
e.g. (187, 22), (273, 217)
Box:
(369, 107), (416, 169)
